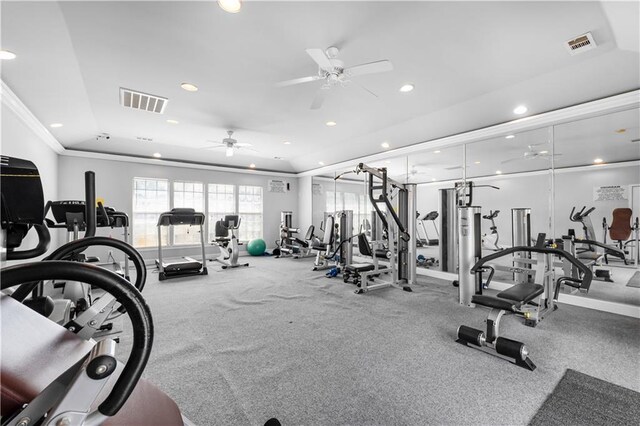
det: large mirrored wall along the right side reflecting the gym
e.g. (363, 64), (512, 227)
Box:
(313, 105), (640, 306)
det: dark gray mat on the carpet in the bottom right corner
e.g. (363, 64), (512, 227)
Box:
(529, 369), (640, 426)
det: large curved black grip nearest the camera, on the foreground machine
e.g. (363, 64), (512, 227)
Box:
(0, 262), (153, 417)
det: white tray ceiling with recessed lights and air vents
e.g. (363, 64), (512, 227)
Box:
(0, 1), (640, 171)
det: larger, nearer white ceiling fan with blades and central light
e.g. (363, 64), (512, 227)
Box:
(276, 46), (393, 109)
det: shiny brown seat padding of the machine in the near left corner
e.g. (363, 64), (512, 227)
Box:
(0, 296), (184, 426)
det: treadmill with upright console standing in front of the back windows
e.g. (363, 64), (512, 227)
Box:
(156, 208), (207, 281)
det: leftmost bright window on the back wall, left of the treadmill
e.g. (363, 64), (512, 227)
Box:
(132, 178), (169, 247)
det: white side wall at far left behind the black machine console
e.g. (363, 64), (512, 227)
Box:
(0, 103), (58, 260)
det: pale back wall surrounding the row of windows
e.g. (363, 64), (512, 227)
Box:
(58, 155), (298, 260)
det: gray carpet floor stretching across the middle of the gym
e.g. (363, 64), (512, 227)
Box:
(120, 257), (640, 425)
